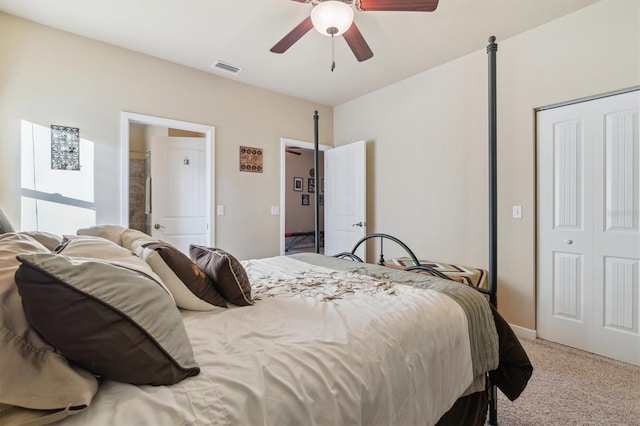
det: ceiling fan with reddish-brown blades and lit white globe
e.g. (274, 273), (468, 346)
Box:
(271, 0), (439, 71)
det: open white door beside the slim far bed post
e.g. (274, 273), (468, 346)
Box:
(324, 141), (367, 260)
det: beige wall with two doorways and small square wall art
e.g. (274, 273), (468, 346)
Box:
(0, 13), (333, 258)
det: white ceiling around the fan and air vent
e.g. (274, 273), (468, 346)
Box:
(0, 0), (599, 106)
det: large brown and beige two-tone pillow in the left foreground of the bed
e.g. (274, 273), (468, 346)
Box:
(15, 253), (200, 385)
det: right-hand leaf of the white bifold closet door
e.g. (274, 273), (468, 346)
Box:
(593, 101), (640, 365)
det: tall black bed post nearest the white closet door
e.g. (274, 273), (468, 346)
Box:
(487, 36), (498, 425)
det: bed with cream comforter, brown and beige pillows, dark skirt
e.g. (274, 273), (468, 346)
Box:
(0, 225), (531, 425)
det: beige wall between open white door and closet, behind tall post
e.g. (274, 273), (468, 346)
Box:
(334, 0), (640, 329)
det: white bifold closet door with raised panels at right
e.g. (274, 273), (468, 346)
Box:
(537, 91), (640, 365)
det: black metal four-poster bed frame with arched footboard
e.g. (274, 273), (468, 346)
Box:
(313, 36), (498, 425)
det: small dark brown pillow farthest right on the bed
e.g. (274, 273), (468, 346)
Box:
(189, 244), (254, 306)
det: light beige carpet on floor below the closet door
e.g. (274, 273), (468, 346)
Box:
(498, 339), (640, 426)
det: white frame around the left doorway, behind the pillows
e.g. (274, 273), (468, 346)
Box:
(120, 111), (216, 245)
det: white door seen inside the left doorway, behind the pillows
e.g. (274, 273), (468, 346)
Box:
(151, 136), (211, 255)
